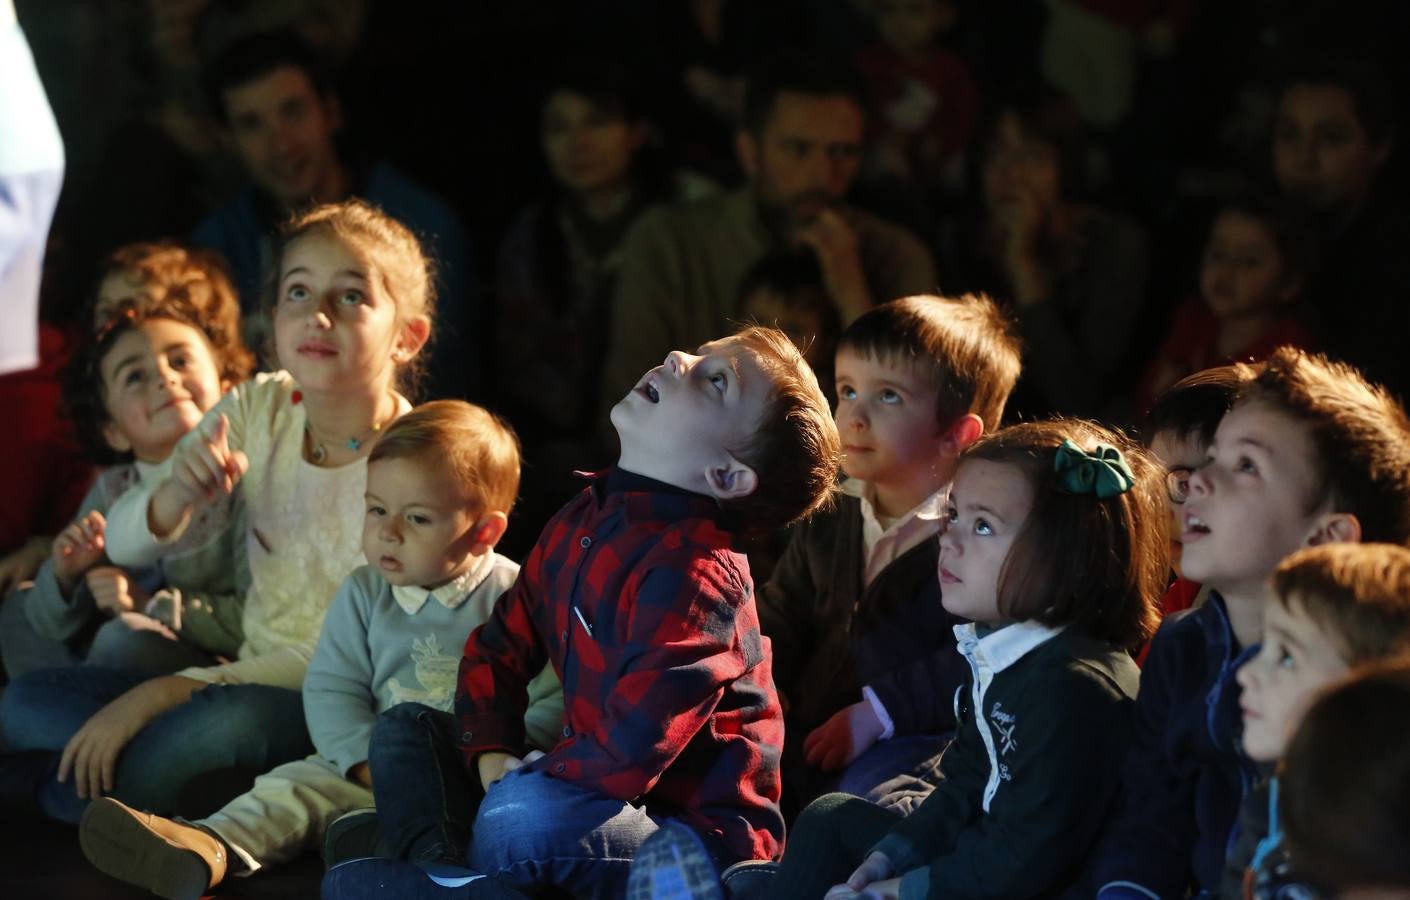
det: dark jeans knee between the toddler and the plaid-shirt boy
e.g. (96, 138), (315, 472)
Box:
(367, 703), (485, 865)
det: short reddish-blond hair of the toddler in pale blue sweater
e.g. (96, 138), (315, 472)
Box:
(367, 401), (519, 513)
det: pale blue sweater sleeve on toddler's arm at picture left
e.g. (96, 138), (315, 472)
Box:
(303, 573), (376, 774)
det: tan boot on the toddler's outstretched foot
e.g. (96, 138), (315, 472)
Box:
(79, 797), (227, 900)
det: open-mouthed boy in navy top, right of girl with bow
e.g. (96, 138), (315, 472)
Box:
(1079, 347), (1410, 900)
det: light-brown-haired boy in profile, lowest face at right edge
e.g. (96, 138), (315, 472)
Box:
(1220, 543), (1410, 900)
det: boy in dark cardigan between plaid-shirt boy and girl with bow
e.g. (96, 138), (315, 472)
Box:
(760, 296), (1019, 808)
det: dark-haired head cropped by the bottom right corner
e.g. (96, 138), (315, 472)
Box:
(1277, 660), (1410, 896)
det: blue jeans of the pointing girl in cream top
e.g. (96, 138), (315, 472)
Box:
(0, 666), (313, 822)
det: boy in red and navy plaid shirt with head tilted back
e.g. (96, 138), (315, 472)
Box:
(323, 327), (838, 899)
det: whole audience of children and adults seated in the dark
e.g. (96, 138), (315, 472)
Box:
(0, 0), (1410, 900)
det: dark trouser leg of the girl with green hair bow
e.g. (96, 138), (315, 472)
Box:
(770, 794), (904, 900)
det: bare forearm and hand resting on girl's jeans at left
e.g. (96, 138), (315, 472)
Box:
(58, 676), (206, 798)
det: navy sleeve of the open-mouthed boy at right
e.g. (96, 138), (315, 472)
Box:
(1086, 622), (1196, 900)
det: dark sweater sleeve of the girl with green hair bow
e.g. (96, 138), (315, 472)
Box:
(879, 663), (1131, 899)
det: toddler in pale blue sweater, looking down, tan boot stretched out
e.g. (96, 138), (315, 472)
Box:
(79, 401), (563, 900)
